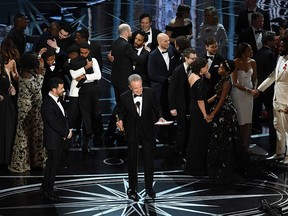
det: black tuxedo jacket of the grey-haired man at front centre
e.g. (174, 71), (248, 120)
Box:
(118, 87), (162, 144)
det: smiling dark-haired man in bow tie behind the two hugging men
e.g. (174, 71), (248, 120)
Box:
(131, 13), (161, 51)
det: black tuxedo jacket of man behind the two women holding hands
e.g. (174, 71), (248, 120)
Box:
(202, 52), (225, 99)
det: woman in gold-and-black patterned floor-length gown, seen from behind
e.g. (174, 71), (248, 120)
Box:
(8, 52), (46, 173)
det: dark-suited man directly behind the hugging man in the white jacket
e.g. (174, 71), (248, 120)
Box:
(75, 28), (103, 71)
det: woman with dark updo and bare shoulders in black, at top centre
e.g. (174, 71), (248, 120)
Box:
(165, 4), (192, 45)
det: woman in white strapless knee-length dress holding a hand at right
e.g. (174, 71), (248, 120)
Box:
(231, 43), (258, 150)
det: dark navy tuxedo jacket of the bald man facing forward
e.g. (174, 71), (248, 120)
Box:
(148, 46), (178, 84)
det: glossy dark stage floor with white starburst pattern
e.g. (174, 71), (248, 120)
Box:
(0, 137), (288, 216)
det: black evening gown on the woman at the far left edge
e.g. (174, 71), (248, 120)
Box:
(0, 72), (16, 165)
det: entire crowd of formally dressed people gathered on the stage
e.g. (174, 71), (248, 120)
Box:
(0, 0), (288, 201)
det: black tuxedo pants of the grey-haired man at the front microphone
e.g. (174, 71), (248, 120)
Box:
(128, 136), (154, 190)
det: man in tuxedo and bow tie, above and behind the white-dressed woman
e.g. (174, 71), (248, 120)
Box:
(237, 12), (265, 58)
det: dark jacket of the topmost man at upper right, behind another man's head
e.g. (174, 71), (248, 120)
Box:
(235, 7), (271, 35)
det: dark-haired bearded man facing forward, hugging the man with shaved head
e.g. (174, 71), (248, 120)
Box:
(134, 31), (150, 86)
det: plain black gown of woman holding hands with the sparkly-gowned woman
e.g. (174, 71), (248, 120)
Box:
(184, 78), (210, 175)
